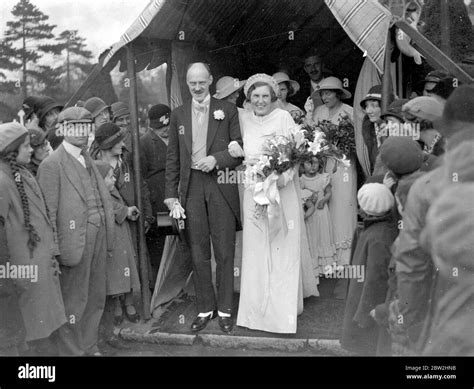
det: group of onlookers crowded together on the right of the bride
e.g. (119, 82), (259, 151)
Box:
(341, 71), (474, 355)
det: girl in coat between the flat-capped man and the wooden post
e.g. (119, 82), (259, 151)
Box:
(95, 161), (140, 325)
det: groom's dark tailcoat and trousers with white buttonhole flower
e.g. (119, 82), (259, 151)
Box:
(165, 98), (242, 314)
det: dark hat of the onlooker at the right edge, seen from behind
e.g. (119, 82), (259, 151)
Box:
(436, 85), (474, 137)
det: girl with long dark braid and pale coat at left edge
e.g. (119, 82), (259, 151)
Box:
(0, 123), (66, 351)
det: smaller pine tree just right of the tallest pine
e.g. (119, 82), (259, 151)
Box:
(56, 30), (92, 95)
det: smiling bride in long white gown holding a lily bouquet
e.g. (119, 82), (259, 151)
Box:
(229, 74), (319, 333)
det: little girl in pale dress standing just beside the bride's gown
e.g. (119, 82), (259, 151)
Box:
(300, 156), (336, 274)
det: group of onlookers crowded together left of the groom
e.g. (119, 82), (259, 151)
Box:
(0, 96), (170, 355)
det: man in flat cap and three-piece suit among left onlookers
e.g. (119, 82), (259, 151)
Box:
(37, 107), (114, 355)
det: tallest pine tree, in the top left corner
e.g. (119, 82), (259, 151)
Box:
(0, 0), (60, 97)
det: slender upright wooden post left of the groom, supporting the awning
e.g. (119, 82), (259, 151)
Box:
(127, 43), (151, 319)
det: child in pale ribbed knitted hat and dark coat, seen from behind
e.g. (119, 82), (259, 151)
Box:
(341, 183), (398, 355)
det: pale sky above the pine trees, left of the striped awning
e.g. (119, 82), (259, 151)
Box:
(0, 0), (150, 58)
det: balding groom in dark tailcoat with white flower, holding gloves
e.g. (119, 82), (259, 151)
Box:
(164, 62), (242, 332)
